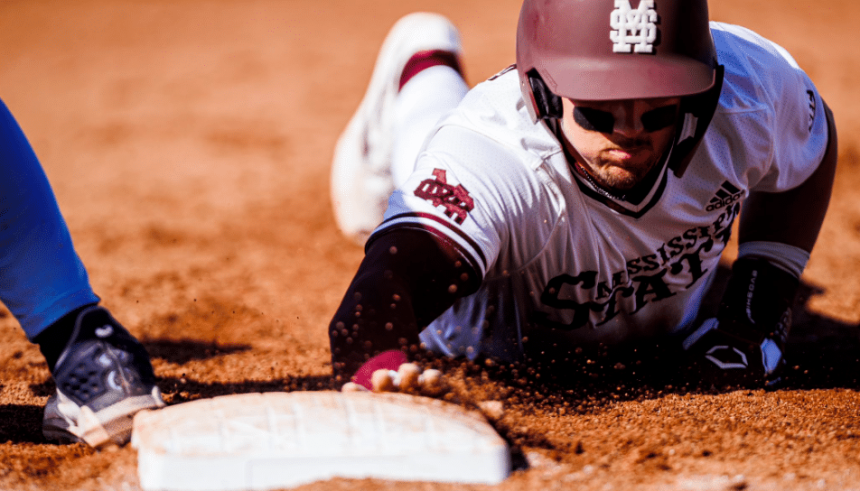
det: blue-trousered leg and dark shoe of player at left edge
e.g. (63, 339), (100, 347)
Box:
(0, 97), (164, 448)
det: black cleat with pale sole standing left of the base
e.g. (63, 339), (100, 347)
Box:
(42, 306), (165, 448)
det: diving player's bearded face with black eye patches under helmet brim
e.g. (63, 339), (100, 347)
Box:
(562, 97), (680, 191)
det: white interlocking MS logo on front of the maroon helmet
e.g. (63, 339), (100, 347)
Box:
(609, 0), (657, 53)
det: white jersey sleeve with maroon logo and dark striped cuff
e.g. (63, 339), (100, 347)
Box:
(370, 126), (531, 277)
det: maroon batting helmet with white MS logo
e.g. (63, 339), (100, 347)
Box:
(517, 0), (723, 174)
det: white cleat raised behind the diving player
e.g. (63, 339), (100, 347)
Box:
(331, 12), (462, 245)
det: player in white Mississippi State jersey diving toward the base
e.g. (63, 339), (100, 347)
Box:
(328, 0), (837, 388)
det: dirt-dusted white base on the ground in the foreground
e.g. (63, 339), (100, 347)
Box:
(131, 391), (511, 491)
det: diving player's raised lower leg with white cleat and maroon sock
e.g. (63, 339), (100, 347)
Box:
(331, 13), (465, 244)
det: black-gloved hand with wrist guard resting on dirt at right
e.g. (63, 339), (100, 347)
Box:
(684, 259), (798, 388)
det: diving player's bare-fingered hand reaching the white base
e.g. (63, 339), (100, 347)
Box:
(341, 351), (445, 396)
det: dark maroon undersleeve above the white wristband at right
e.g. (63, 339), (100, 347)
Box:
(738, 105), (837, 252)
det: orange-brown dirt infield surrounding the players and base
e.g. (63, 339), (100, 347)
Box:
(0, 0), (860, 491)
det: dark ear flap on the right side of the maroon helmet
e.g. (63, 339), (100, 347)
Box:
(668, 65), (725, 178)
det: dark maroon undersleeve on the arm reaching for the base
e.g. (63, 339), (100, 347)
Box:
(329, 228), (481, 384)
